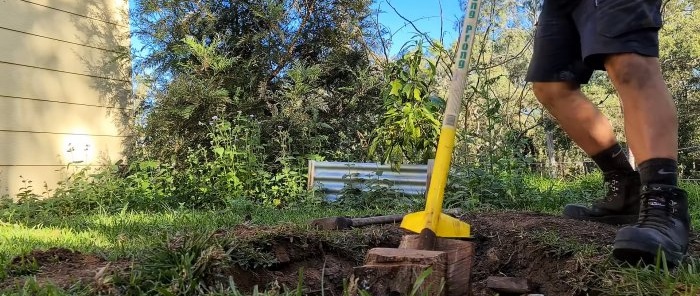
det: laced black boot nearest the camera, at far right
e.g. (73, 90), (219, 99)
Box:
(613, 185), (690, 267)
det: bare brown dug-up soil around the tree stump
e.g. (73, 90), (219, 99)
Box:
(0, 212), (700, 296)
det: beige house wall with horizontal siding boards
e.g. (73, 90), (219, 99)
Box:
(0, 0), (131, 196)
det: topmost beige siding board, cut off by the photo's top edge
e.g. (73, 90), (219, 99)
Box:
(20, 0), (129, 26)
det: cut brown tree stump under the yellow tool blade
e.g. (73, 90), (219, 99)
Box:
(349, 234), (474, 296)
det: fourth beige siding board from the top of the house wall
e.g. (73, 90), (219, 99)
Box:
(0, 63), (130, 107)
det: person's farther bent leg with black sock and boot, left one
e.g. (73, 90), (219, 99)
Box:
(533, 82), (639, 224)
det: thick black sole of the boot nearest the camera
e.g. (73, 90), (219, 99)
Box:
(613, 240), (684, 268)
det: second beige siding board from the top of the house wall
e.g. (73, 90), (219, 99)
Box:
(0, 0), (129, 50)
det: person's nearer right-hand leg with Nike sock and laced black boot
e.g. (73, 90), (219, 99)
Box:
(605, 54), (690, 263)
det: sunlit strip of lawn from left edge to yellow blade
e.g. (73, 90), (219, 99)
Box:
(0, 202), (402, 258)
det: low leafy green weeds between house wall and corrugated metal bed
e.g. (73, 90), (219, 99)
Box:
(0, 115), (316, 217)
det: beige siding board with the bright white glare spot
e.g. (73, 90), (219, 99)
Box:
(0, 131), (125, 167)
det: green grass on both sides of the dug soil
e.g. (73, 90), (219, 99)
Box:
(0, 175), (700, 295)
